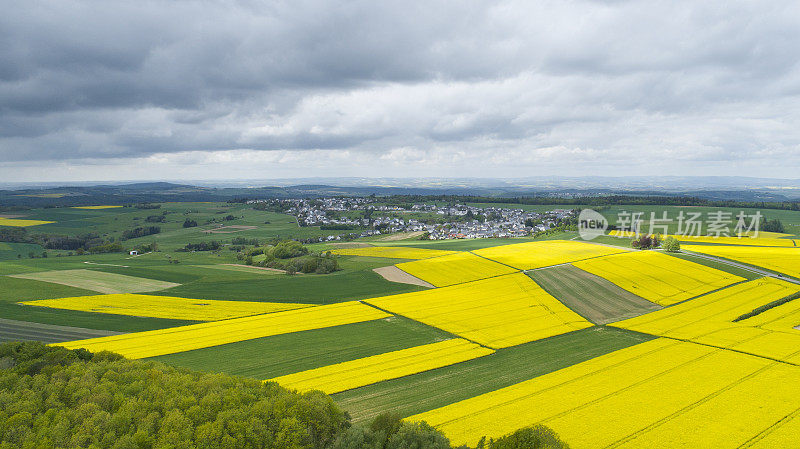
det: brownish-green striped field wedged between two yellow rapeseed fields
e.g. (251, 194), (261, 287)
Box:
(527, 265), (661, 324)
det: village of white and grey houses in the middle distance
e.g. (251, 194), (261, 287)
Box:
(250, 197), (577, 240)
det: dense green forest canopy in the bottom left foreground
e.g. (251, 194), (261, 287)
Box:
(0, 342), (568, 449)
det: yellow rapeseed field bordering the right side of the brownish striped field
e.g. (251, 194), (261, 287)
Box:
(572, 251), (745, 306)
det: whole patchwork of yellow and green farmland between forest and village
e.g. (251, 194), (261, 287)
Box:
(0, 204), (800, 448)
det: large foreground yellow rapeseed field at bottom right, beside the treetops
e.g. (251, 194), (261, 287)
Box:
(409, 339), (800, 449)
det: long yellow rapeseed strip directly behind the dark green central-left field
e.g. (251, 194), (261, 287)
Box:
(54, 301), (391, 359)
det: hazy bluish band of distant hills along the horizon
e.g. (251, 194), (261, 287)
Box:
(0, 178), (800, 209)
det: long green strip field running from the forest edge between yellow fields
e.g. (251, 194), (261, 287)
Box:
(333, 327), (654, 422)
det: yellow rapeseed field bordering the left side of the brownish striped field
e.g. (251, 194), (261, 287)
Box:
(365, 273), (592, 348)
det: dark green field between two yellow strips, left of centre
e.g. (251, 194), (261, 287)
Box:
(152, 317), (452, 379)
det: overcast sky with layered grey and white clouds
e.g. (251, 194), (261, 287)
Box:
(0, 0), (800, 181)
